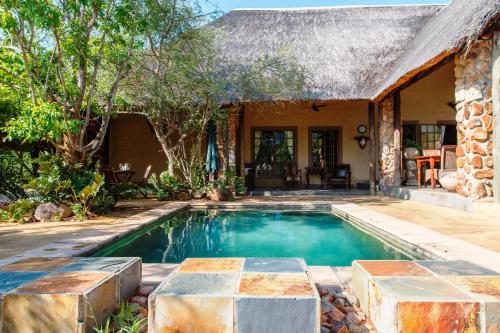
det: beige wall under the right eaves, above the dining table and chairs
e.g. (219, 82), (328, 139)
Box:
(401, 62), (455, 124)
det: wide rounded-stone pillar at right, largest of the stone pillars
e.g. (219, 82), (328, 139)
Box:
(455, 37), (493, 200)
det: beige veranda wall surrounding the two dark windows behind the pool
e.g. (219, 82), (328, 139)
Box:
(244, 101), (370, 183)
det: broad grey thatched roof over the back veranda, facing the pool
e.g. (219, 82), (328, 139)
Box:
(213, 4), (442, 100)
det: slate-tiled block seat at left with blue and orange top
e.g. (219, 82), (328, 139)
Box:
(0, 257), (141, 333)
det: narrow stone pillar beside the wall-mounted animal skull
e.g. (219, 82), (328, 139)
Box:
(379, 96), (394, 186)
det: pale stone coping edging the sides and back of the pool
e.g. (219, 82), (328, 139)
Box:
(0, 200), (500, 272)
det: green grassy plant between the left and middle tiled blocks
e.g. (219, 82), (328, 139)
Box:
(94, 302), (147, 333)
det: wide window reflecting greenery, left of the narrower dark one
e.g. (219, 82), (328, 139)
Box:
(254, 129), (296, 164)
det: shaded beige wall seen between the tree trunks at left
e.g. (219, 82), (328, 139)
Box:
(109, 114), (167, 180)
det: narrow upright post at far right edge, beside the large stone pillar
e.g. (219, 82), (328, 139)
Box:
(491, 31), (500, 205)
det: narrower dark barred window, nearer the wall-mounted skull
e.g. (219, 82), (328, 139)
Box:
(309, 128), (340, 169)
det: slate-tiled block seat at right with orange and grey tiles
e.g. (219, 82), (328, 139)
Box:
(352, 260), (500, 333)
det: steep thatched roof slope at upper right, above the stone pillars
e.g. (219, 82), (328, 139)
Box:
(372, 0), (500, 99)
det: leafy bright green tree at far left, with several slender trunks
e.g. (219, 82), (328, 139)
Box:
(0, 0), (144, 163)
